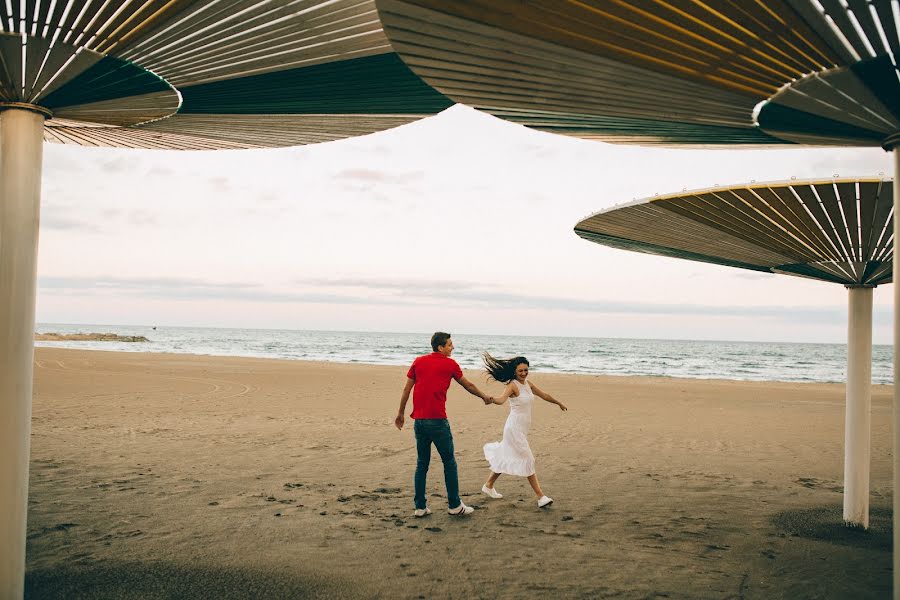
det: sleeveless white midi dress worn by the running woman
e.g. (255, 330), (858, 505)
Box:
(484, 379), (534, 477)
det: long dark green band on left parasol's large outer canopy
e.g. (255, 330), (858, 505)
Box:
(179, 53), (453, 115)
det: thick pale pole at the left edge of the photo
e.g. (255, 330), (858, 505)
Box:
(0, 105), (44, 600)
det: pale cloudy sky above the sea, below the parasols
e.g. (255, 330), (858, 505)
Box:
(36, 106), (892, 344)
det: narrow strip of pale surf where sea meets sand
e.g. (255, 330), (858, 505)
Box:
(29, 341), (893, 390)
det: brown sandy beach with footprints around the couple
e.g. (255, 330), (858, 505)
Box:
(26, 348), (891, 599)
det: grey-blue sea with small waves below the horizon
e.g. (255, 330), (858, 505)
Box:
(35, 323), (893, 384)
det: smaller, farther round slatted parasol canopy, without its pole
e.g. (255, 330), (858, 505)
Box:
(575, 179), (894, 286)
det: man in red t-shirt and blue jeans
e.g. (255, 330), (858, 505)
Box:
(394, 331), (492, 517)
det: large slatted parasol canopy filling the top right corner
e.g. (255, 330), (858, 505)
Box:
(376, 0), (900, 146)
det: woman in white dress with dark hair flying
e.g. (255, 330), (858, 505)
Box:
(481, 352), (568, 508)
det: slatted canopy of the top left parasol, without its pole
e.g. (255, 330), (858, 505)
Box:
(0, 0), (452, 150)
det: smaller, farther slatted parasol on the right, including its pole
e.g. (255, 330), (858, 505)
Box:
(575, 178), (895, 528)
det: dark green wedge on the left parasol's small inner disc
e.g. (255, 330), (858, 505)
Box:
(40, 56), (172, 110)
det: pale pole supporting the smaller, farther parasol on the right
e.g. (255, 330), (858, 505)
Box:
(844, 287), (872, 529)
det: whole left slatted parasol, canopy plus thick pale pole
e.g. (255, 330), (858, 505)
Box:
(0, 0), (452, 598)
